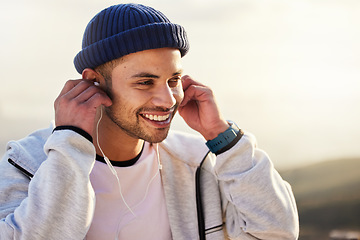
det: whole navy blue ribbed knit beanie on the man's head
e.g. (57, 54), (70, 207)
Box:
(74, 4), (189, 74)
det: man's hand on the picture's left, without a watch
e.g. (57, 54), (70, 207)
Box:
(54, 79), (112, 135)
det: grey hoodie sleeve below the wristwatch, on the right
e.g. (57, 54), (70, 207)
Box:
(213, 134), (299, 240)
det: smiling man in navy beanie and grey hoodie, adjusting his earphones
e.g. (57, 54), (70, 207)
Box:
(0, 4), (298, 240)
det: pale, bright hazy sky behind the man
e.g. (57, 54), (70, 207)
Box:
(0, 0), (360, 169)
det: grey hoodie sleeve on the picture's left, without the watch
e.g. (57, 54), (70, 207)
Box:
(0, 130), (95, 240)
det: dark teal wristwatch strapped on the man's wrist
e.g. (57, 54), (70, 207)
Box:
(206, 121), (242, 153)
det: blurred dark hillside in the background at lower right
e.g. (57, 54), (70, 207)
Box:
(281, 159), (360, 240)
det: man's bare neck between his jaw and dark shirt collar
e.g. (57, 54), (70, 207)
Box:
(93, 109), (144, 161)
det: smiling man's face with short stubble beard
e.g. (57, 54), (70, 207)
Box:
(106, 48), (184, 143)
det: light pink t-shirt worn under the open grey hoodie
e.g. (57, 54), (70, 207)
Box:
(86, 143), (171, 240)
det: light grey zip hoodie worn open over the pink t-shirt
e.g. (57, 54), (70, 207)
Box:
(0, 124), (299, 240)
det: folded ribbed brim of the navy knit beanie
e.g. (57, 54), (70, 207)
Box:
(74, 22), (189, 74)
